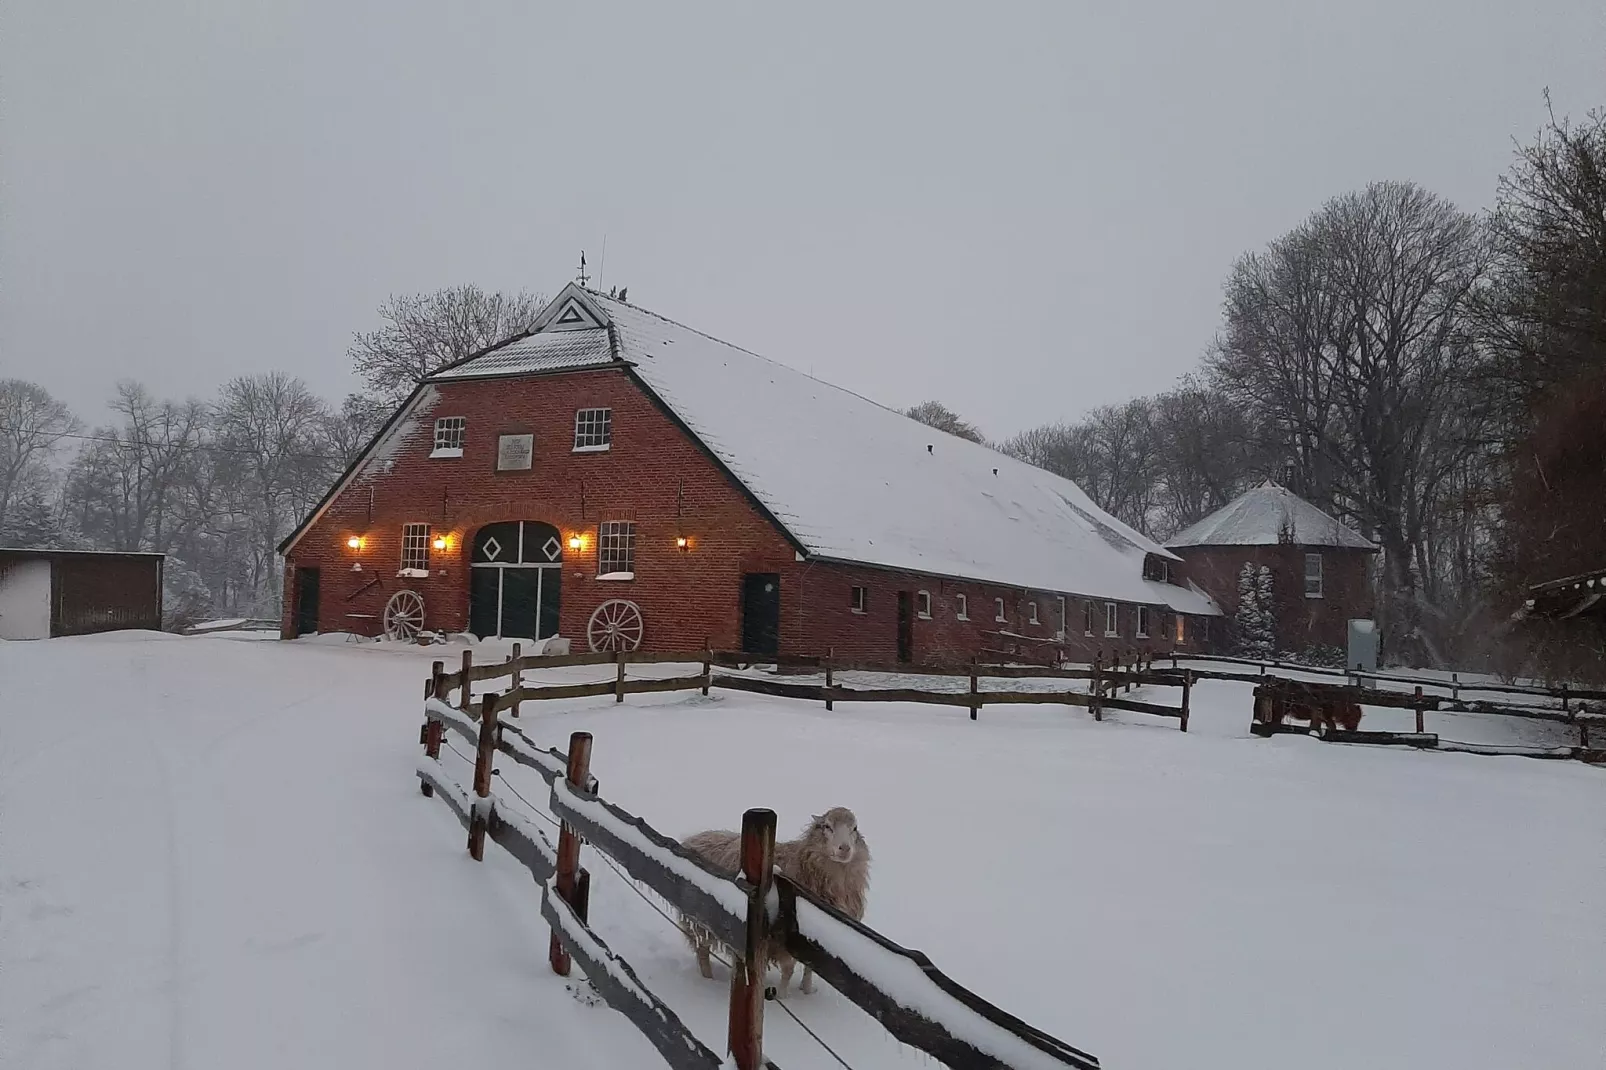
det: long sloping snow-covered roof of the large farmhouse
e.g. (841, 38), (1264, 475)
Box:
(434, 284), (1219, 614)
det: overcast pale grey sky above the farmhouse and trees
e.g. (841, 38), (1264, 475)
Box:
(0, 0), (1606, 435)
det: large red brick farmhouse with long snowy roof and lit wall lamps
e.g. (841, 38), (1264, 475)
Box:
(279, 284), (1219, 662)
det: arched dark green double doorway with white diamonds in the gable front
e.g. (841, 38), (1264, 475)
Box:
(469, 521), (564, 639)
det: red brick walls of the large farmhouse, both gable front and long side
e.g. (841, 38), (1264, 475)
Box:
(283, 370), (1198, 662)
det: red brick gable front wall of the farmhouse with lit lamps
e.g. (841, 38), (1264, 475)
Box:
(283, 370), (795, 649)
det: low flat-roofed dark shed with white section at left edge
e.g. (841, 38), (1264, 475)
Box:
(0, 548), (164, 639)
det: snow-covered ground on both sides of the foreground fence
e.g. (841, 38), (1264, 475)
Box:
(0, 633), (1606, 1070)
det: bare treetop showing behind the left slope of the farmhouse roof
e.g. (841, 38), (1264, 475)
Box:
(347, 284), (546, 403)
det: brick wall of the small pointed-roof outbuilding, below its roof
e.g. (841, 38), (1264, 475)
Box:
(1174, 545), (1376, 651)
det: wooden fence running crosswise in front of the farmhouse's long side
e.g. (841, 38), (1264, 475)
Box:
(427, 643), (1198, 731)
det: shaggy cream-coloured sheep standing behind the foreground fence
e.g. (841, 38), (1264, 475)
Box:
(681, 807), (870, 998)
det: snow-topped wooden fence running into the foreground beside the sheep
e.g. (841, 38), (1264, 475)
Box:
(418, 672), (1099, 1070)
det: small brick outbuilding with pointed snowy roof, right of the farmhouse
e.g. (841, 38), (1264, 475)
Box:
(1166, 480), (1378, 652)
